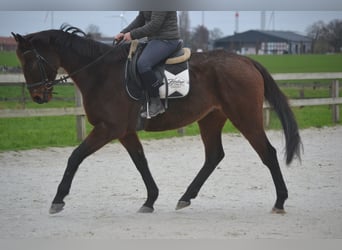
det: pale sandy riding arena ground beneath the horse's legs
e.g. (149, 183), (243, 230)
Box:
(0, 126), (342, 239)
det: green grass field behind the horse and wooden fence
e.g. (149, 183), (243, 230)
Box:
(0, 53), (342, 151)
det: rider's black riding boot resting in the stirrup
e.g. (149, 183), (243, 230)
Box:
(140, 71), (165, 119)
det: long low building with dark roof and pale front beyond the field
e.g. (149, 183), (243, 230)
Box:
(213, 30), (312, 54)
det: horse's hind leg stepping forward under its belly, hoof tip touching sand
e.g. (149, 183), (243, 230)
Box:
(176, 110), (226, 209)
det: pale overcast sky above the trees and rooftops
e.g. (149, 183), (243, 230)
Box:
(0, 10), (342, 36)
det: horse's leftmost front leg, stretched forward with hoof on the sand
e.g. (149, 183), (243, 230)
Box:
(49, 124), (113, 214)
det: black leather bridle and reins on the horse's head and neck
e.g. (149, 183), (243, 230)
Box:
(23, 46), (119, 90)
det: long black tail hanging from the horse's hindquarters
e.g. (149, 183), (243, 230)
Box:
(253, 60), (302, 165)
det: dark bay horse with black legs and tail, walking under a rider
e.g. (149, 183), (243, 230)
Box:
(13, 26), (301, 213)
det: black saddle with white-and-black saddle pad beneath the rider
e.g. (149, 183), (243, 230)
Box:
(125, 40), (191, 102)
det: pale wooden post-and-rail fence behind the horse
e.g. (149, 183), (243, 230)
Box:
(0, 72), (342, 140)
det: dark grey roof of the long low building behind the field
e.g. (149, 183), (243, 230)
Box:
(215, 30), (311, 44)
